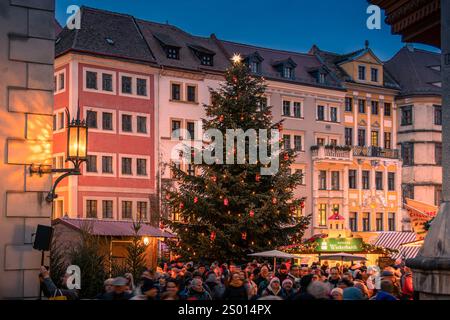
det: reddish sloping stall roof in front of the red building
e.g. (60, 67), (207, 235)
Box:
(53, 218), (174, 238)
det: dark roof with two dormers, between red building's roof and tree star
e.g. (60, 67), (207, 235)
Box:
(136, 19), (229, 72)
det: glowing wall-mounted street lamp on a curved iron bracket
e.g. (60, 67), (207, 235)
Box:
(30, 109), (88, 202)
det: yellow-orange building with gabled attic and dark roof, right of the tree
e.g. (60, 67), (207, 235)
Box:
(310, 43), (403, 237)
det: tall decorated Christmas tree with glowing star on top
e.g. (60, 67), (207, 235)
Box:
(164, 57), (310, 261)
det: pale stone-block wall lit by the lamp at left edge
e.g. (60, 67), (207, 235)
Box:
(0, 0), (55, 299)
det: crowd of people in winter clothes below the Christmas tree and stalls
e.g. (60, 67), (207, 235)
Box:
(41, 261), (414, 301)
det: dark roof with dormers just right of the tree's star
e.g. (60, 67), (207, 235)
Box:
(219, 40), (343, 90)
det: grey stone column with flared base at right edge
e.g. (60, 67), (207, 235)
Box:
(407, 0), (450, 300)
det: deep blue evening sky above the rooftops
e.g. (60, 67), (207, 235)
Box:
(56, 0), (436, 60)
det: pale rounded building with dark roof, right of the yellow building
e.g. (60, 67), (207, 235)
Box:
(386, 45), (442, 206)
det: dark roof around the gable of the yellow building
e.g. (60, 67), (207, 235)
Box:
(309, 45), (400, 90)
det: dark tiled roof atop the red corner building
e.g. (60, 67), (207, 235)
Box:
(55, 6), (156, 63)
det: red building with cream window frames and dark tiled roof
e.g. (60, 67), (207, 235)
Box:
(53, 8), (158, 221)
